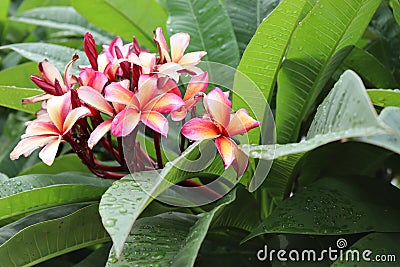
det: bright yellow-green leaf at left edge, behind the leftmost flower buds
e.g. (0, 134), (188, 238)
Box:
(0, 62), (43, 113)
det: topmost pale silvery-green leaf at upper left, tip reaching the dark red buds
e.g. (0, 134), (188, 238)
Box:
(10, 6), (113, 43)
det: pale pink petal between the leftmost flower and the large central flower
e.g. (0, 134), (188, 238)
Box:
(77, 86), (113, 116)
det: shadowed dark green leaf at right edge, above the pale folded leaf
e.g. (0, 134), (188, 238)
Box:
(342, 47), (398, 88)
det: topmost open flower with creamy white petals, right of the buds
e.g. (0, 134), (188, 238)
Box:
(154, 27), (207, 82)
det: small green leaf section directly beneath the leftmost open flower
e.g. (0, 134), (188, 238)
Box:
(18, 154), (90, 175)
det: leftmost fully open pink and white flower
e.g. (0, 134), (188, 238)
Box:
(10, 93), (90, 165)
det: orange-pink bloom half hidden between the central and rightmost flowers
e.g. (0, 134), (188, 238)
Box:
(171, 72), (208, 121)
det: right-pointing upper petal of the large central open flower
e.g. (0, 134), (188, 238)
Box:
(142, 93), (185, 114)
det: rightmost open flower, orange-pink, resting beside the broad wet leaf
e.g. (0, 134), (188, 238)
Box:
(182, 87), (260, 176)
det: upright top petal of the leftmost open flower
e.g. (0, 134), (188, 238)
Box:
(47, 92), (71, 131)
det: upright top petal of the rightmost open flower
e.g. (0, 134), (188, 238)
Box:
(203, 87), (232, 128)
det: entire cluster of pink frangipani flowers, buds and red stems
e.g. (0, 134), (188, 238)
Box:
(10, 28), (259, 179)
